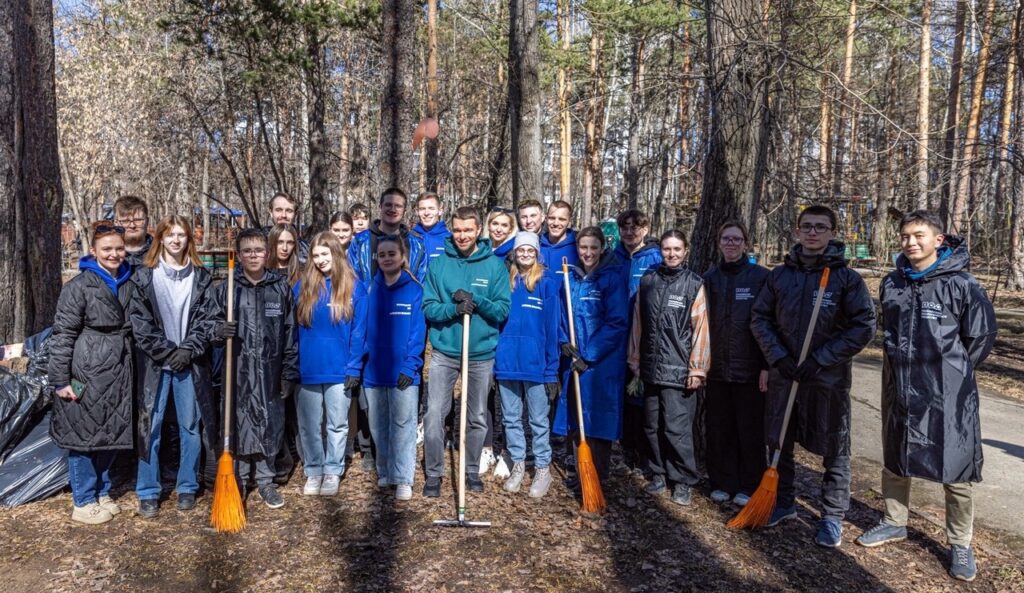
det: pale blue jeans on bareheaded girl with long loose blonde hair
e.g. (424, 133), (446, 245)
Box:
(295, 383), (352, 477)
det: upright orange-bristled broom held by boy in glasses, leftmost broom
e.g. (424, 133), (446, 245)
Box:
(210, 251), (246, 534)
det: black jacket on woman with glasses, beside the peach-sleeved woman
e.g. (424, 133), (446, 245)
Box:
(705, 257), (769, 383)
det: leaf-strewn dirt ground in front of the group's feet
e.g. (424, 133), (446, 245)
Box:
(0, 440), (1024, 593)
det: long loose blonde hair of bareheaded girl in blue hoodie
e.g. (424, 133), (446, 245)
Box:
(295, 230), (355, 328)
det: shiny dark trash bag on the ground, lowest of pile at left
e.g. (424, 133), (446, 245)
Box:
(0, 411), (70, 508)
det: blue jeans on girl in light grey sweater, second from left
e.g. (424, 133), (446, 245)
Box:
(135, 371), (203, 501)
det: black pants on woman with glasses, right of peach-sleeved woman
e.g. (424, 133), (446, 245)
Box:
(705, 381), (767, 495)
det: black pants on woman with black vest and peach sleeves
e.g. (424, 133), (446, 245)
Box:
(644, 383), (700, 485)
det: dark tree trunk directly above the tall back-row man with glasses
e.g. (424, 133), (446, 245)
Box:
(379, 0), (420, 190)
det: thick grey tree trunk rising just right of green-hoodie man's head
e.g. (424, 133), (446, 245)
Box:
(508, 0), (544, 207)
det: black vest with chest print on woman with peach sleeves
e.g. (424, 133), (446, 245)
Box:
(634, 264), (703, 388)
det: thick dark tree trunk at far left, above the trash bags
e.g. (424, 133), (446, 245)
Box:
(0, 0), (63, 343)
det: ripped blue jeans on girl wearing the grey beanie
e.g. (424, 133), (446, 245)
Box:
(498, 381), (551, 468)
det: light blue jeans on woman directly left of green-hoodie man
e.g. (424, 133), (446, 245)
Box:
(362, 385), (420, 485)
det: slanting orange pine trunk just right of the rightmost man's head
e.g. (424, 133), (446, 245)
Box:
(949, 0), (995, 239)
